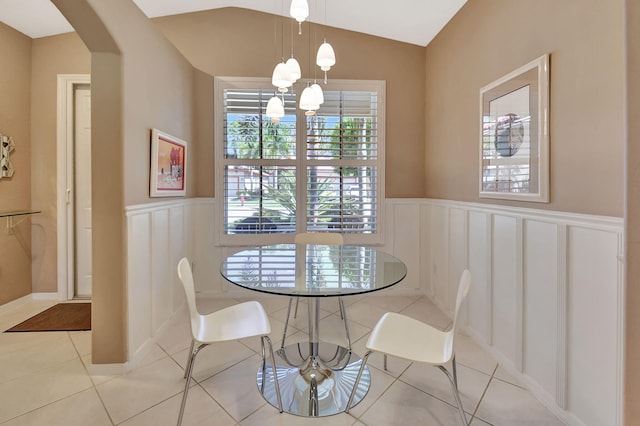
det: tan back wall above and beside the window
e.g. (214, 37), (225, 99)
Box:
(154, 8), (425, 198)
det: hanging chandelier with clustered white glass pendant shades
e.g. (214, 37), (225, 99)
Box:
(266, 0), (336, 118)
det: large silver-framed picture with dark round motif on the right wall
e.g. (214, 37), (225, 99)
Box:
(480, 55), (549, 203)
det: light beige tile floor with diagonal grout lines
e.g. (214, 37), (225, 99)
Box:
(0, 296), (562, 426)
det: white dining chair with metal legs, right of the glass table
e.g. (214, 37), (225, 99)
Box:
(345, 269), (471, 425)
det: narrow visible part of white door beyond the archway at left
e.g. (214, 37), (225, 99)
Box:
(73, 85), (92, 298)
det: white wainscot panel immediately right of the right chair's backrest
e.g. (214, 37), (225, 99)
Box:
(467, 210), (493, 345)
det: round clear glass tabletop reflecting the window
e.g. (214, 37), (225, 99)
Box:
(220, 244), (407, 297)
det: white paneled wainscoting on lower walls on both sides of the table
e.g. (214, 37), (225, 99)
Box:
(126, 198), (624, 426)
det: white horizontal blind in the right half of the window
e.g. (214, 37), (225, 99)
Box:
(305, 90), (379, 233)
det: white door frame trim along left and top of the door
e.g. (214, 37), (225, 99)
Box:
(56, 74), (91, 300)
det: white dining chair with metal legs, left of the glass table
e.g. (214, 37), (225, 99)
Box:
(178, 258), (282, 426)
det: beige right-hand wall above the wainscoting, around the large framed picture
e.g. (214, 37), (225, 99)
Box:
(425, 0), (624, 217)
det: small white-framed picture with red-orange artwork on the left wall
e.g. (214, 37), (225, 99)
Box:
(149, 129), (187, 197)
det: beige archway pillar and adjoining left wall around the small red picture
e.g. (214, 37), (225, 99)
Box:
(54, 0), (198, 364)
